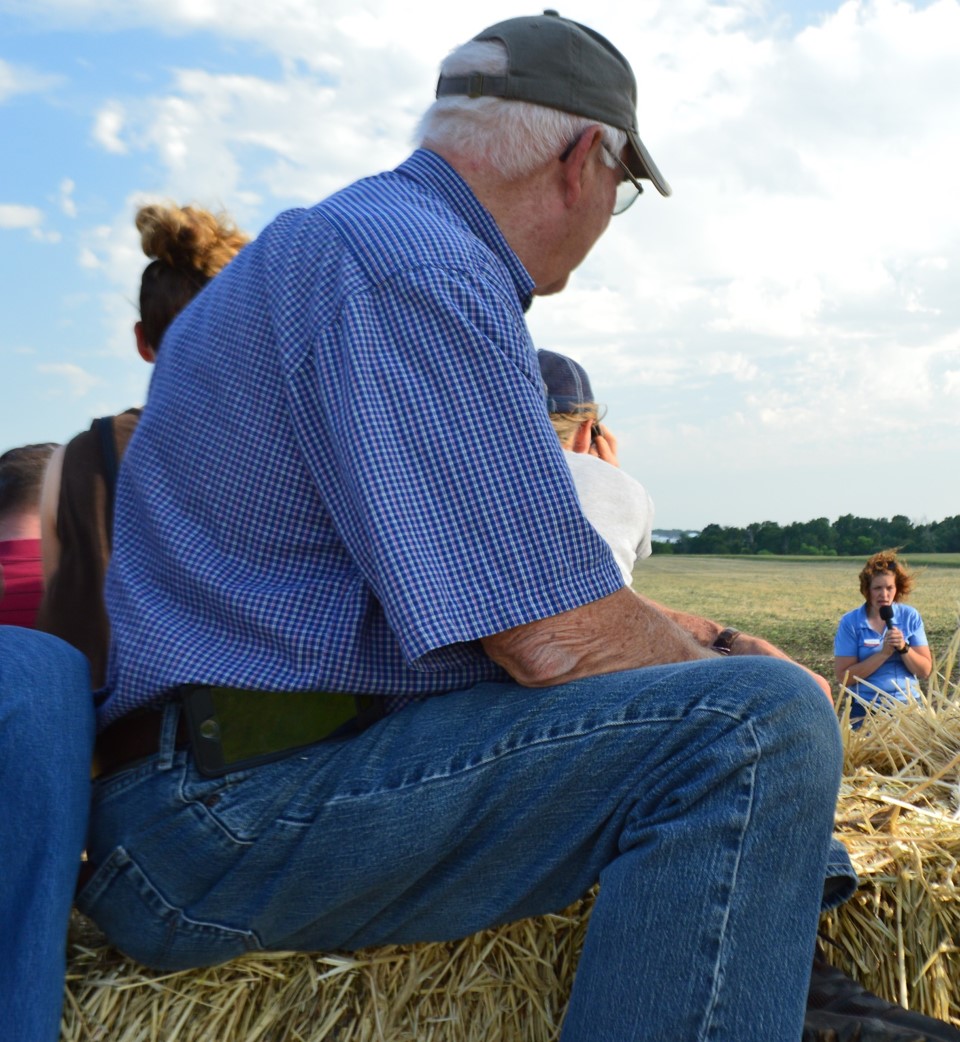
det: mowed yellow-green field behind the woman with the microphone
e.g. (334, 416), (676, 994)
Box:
(634, 553), (960, 684)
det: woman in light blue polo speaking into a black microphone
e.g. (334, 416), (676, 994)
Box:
(833, 550), (933, 720)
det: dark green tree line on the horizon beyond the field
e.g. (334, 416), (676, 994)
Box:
(654, 514), (960, 556)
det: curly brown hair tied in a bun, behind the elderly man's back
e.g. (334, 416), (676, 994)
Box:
(137, 203), (250, 350)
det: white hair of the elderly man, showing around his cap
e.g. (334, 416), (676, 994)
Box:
(416, 40), (626, 180)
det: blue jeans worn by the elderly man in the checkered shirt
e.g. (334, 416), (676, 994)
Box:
(79, 658), (848, 1042)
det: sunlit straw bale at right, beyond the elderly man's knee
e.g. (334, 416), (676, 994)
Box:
(821, 630), (960, 1023)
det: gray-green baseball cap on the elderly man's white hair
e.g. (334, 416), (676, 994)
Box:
(437, 10), (670, 196)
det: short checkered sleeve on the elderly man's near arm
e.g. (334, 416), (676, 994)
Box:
(285, 269), (621, 668)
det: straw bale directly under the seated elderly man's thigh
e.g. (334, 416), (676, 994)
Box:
(60, 895), (593, 1042)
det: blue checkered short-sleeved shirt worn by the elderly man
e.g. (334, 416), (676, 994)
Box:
(100, 150), (622, 726)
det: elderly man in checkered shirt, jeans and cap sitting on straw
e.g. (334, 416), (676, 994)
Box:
(79, 11), (950, 1042)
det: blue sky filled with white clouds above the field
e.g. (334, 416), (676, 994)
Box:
(0, 0), (960, 527)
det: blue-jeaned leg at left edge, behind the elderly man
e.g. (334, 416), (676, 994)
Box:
(0, 626), (94, 1042)
